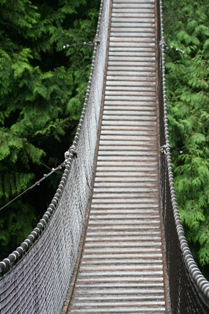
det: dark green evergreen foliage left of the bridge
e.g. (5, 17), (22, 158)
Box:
(0, 0), (100, 260)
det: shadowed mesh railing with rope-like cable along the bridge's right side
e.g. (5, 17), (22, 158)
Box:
(157, 1), (209, 314)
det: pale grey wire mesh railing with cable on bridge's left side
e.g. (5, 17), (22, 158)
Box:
(0, 0), (110, 314)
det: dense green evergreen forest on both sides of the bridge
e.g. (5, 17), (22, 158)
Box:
(0, 0), (209, 278)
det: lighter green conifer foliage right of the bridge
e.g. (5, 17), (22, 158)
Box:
(163, 0), (209, 279)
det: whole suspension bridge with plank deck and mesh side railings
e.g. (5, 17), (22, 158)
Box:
(0, 0), (209, 314)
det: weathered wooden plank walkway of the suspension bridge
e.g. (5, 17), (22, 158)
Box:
(68, 0), (166, 314)
